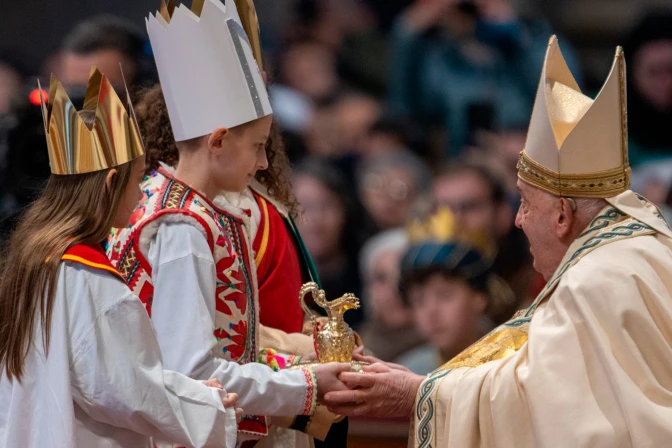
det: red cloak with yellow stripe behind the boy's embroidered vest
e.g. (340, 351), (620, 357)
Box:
(252, 192), (303, 333)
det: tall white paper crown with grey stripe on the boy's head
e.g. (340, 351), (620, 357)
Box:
(146, 0), (273, 142)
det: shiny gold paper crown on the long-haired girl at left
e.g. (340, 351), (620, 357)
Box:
(38, 67), (144, 175)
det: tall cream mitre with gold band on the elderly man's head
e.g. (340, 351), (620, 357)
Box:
(518, 36), (630, 198)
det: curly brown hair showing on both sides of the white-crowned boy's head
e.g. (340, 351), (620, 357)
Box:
(135, 84), (297, 217)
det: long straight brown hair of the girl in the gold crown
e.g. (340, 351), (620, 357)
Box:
(0, 114), (133, 381)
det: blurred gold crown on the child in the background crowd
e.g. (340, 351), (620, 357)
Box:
(407, 207), (495, 258)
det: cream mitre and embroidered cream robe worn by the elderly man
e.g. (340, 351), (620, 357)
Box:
(412, 38), (672, 448)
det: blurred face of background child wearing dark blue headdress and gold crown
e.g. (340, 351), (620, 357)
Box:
(408, 273), (487, 357)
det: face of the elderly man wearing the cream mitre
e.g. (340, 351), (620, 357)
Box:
(516, 179), (566, 280)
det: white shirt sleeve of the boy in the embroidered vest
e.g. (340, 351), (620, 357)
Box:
(147, 221), (308, 416)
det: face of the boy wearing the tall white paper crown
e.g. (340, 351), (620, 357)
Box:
(212, 115), (273, 192)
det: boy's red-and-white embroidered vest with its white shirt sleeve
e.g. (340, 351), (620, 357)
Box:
(108, 169), (317, 437)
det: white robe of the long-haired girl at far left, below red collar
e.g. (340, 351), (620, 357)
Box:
(0, 262), (237, 448)
